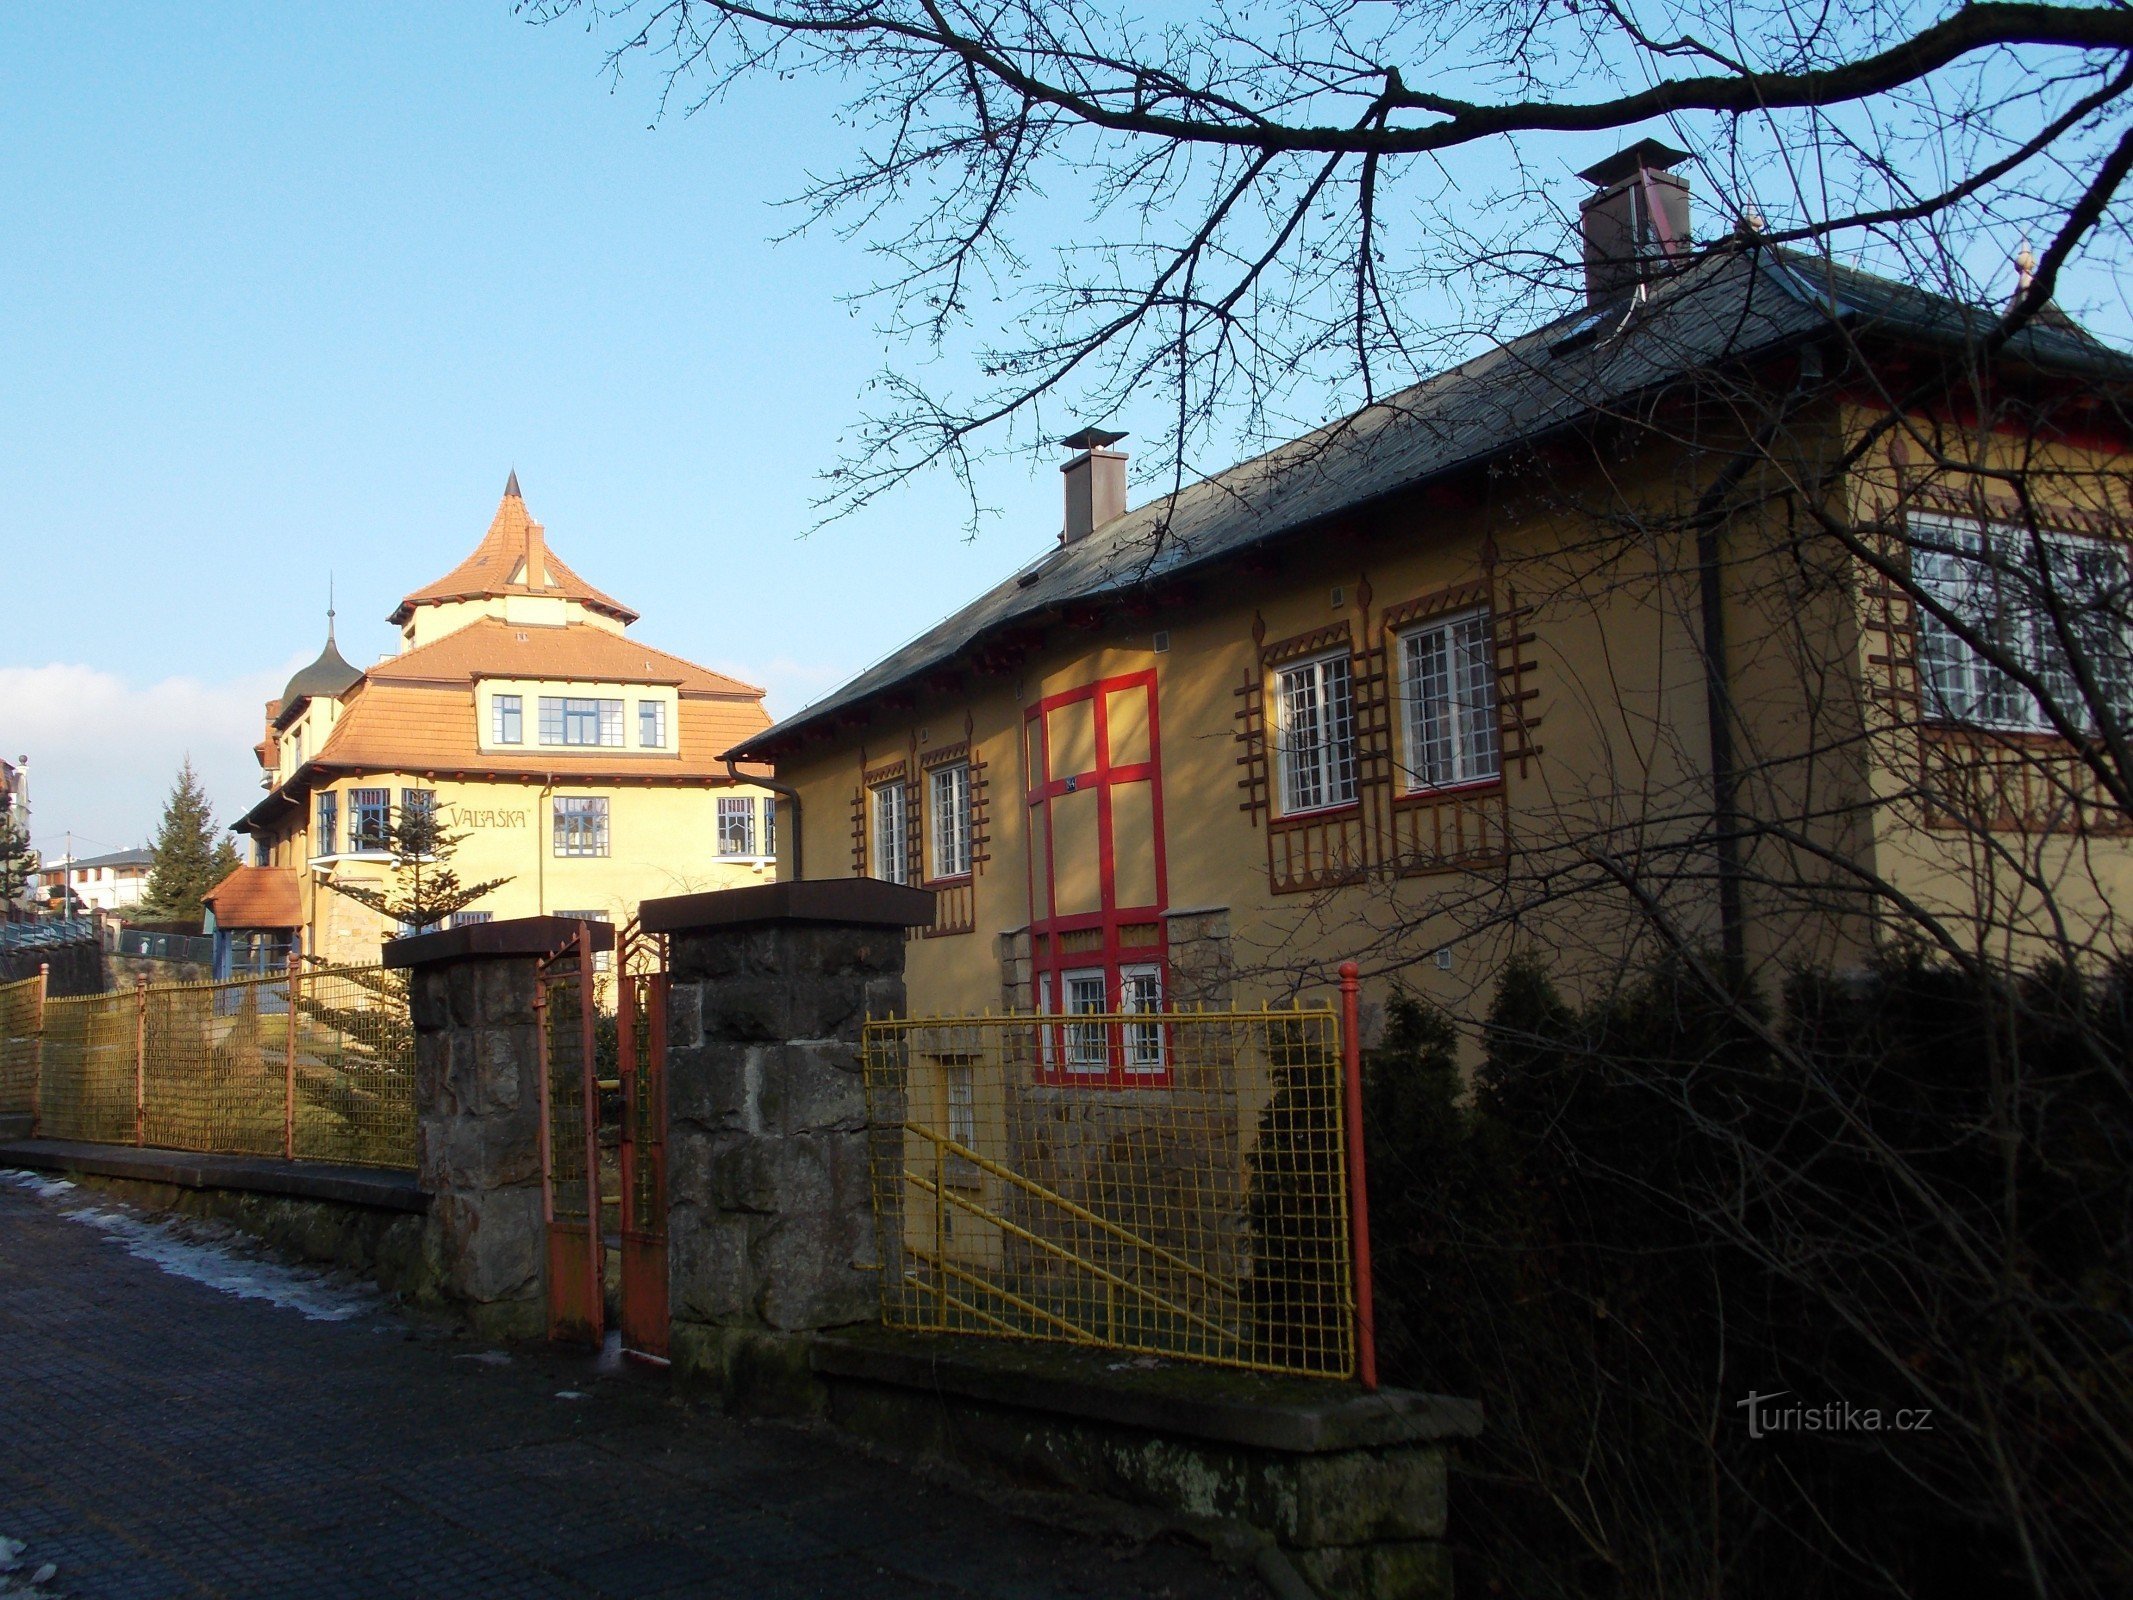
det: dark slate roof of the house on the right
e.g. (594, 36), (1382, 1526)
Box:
(729, 245), (2133, 757)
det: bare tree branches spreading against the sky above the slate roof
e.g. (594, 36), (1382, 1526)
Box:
(520, 0), (2133, 514)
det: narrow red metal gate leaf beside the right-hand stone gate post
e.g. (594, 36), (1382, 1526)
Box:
(614, 924), (668, 1365)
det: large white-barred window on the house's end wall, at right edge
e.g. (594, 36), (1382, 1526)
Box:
(1907, 514), (2133, 734)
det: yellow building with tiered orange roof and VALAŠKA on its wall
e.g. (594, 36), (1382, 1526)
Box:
(211, 474), (776, 969)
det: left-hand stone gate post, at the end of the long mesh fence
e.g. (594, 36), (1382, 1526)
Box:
(384, 917), (614, 1340)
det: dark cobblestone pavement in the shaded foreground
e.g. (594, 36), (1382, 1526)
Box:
(0, 1182), (1258, 1600)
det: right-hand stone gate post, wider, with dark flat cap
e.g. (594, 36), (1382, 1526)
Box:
(638, 879), (932, 1410)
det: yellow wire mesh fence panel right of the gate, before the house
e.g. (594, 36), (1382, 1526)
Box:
(864, 1011), (1354, 1378)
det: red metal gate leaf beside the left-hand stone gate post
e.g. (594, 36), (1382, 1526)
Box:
(533, 926), (606, 1344)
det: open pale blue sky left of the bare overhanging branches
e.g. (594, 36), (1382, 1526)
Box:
(0, 0), (1060, 849)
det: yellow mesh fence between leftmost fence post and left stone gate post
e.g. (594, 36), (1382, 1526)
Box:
(38, 966), (414, 1167)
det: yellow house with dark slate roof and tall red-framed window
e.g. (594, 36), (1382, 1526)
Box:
(734, 147), (2133, 1032)
